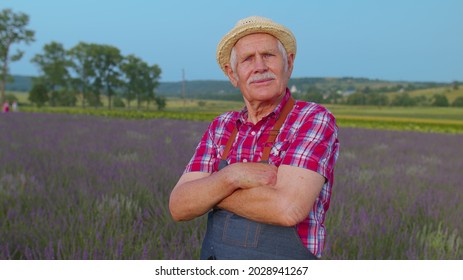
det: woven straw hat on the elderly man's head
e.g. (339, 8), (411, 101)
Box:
(217, 16), (296, 75)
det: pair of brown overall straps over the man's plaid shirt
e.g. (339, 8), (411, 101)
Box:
(220, 97), (295, 166)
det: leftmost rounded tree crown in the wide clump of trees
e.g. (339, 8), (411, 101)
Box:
(31, 42), (71, 91)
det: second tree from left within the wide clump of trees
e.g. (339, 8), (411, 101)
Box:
(68, 42), (95, 107)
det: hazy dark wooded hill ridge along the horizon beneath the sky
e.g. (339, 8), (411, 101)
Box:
(6, 75), (450, 100)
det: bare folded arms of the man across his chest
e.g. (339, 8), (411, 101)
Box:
(169, 163), (325, 226)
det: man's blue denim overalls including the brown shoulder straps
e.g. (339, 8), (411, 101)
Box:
(200, 98), (317, 260)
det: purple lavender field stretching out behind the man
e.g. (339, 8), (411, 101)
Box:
(0, 113), (463, 259)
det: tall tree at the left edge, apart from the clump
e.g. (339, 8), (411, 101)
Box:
(0, 9), (34, 100)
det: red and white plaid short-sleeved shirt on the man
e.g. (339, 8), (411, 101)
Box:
(185, 89), (339, 257)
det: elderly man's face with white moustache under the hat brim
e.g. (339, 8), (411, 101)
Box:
(226, 33), (294, 102)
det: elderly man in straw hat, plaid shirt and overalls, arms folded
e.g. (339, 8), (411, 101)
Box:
(169, 17), (339, 259)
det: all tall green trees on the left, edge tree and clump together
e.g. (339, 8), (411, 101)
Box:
(0, 9), (166, 109)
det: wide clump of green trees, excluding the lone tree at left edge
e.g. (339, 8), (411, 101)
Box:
(27, 42), (161, 109)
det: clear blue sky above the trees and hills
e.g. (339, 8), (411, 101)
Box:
(0, 0), (463, 82)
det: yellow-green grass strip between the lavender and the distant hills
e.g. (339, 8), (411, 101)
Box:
(6, 89), (463, 133)
